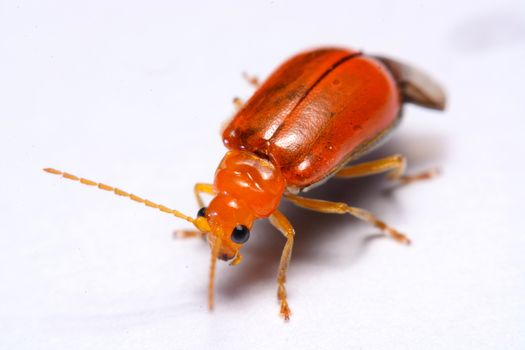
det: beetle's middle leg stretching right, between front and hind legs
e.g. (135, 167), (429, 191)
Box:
(284, 193), (410, 244)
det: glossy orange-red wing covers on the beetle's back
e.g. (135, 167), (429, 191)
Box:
(223, 49), (401, 189)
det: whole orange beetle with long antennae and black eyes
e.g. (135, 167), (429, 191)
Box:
(44, 47), (445, 320)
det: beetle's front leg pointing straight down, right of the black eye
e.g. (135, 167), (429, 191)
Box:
(269, 210), (295, 321)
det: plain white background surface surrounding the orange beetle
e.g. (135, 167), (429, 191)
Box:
(0, 0), (525, 349)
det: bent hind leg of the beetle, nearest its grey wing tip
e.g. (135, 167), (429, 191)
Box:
(335, 154), (438, 185)
